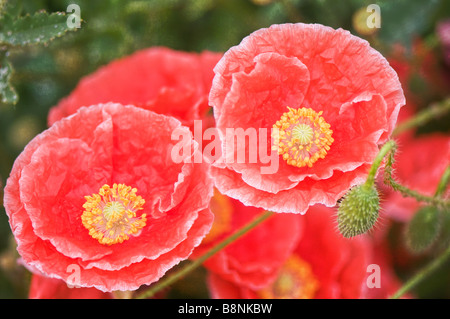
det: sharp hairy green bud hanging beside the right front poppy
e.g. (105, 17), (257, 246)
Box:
(338, 185), (380, 238)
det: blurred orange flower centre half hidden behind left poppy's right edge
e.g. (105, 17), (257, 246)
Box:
(202, 189), (233, 244)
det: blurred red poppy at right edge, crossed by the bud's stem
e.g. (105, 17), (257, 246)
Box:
(382, 133), (450, 221)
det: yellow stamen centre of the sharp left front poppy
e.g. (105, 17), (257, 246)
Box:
(81, 184), (147, 245)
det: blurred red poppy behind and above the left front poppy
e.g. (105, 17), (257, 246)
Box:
(48, 47), (222, 126)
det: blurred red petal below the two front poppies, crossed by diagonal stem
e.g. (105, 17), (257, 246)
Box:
(204, 202), (302, 289)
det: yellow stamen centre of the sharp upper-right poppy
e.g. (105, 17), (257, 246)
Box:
(272, 107), (334, 167)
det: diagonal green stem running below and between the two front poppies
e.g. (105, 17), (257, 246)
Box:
(136, 211), (275, 299)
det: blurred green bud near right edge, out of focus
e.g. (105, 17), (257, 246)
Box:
(406, 206), (440, 254)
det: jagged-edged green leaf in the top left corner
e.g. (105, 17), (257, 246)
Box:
(0, 12), (76, 46)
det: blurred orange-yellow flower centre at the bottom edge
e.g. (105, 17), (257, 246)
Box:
(257, 255), (319, 299)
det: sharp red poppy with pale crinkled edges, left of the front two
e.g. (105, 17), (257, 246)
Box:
(4, 103), (213, 291)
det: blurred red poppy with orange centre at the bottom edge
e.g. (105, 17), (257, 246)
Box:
(208, 205), (372, 299)
